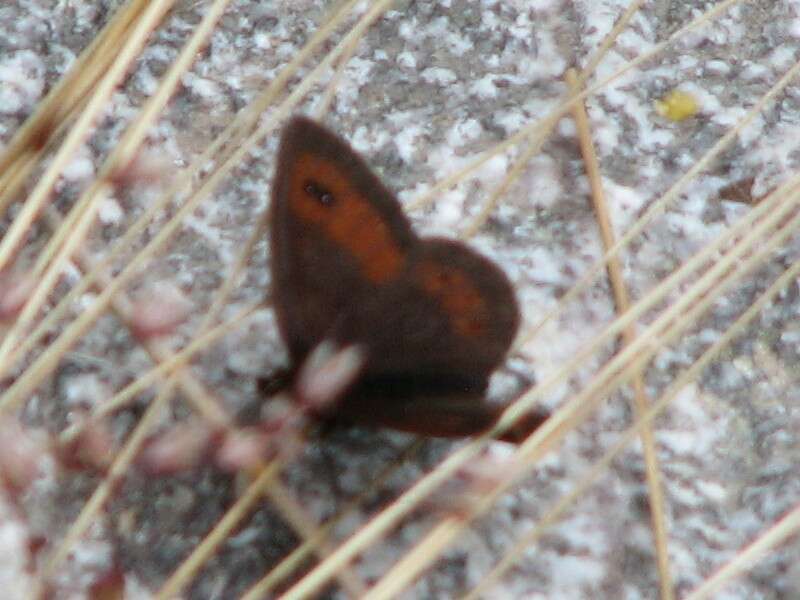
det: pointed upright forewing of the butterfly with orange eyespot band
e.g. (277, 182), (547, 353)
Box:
(271, 117), (415, 361)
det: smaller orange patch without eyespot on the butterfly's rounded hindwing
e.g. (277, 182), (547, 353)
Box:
(416, 261), (489, 338)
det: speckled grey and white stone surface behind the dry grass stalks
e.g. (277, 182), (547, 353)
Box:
(0, 0), (800, 599)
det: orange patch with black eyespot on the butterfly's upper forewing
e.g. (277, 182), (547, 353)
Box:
(289, 154), (405, 284)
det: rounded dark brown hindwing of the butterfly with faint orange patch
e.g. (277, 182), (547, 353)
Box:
(334, 239), (519, 384)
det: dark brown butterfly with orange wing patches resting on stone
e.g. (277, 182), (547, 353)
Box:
(270, 117), (545, 441)
